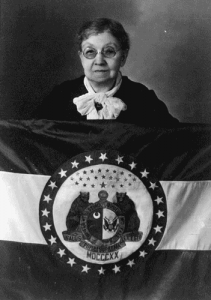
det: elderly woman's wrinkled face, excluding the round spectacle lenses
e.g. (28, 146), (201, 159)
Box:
(79, 31), (127, 88)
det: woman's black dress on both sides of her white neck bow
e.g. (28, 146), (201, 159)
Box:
(33, 76), (179, 126)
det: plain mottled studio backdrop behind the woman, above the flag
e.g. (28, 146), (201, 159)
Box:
(0, 0), (211, 123)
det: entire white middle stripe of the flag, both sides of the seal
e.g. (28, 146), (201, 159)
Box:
(0, 172), (211, 250)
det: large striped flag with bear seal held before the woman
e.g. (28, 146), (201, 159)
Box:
(0, 120), (211, 300)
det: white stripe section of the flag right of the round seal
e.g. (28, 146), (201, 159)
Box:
(157, 181), (211, 250)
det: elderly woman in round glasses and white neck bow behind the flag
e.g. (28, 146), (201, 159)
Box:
(35, 18), (178, 126)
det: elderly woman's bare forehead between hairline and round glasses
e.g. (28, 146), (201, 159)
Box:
(81, 31), (119, 47)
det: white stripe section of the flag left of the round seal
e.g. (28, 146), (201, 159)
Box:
(0, 172), (49, 244)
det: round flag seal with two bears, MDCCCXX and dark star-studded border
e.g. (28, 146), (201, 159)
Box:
(39, 150), (167, 275)
